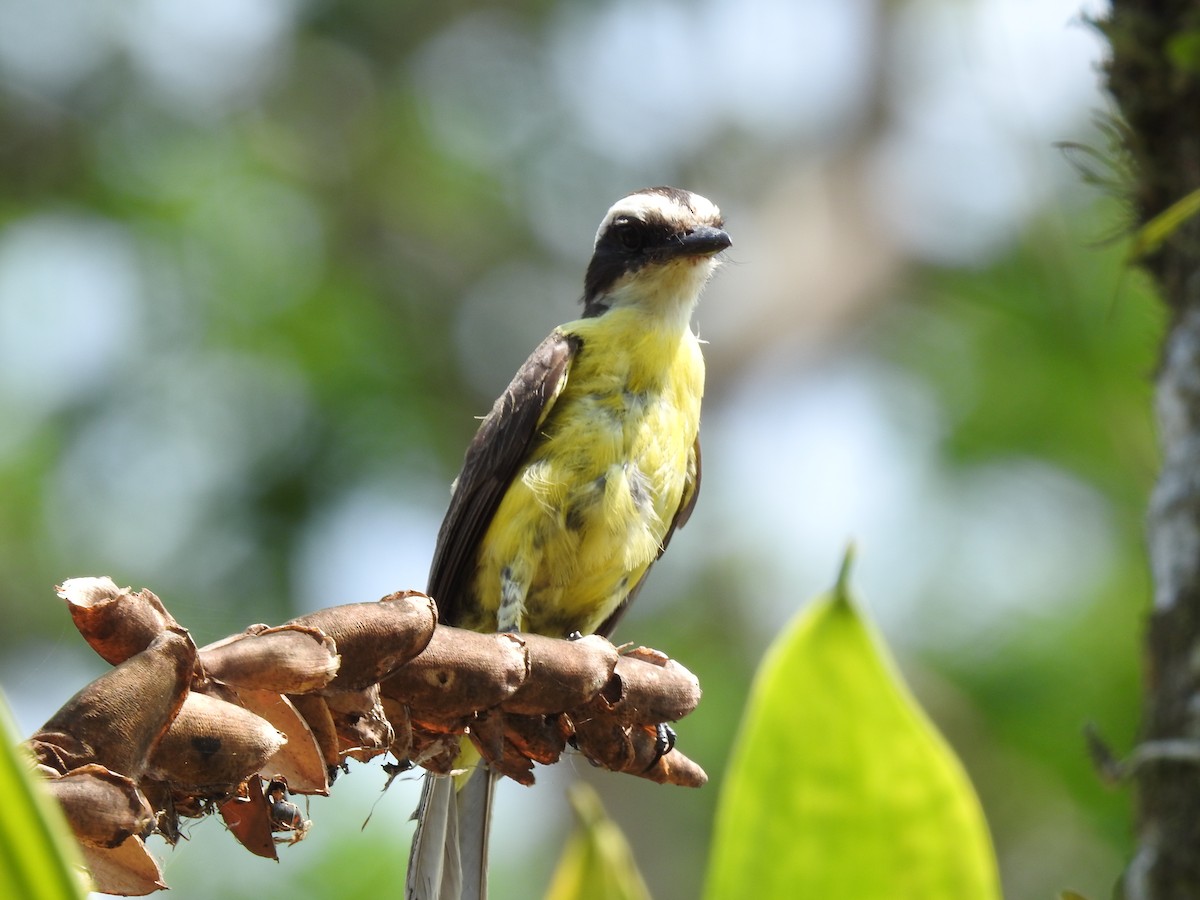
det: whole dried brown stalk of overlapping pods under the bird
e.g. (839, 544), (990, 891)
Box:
(29, 578), (707, 895)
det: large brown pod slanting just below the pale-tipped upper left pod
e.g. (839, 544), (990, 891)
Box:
(30, 631), (196, 780)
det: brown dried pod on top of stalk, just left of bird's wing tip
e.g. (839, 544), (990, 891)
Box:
(288, 590), (438, 690)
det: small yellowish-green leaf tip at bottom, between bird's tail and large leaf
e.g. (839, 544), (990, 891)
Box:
(546, 784), (650, 900)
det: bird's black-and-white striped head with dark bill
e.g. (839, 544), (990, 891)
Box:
(583, 187), (732, 317)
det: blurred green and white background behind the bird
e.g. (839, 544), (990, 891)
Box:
(0, 0), (1162, 900)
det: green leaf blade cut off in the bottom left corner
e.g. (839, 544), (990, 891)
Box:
(0, 695), (86, 900)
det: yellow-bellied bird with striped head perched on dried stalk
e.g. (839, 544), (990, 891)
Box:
(406, 187), (732, 900)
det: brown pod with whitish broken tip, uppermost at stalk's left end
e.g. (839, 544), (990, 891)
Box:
(56, 577), (181, 666)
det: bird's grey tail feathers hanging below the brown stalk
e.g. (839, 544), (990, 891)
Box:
(404, 762), (496, 900)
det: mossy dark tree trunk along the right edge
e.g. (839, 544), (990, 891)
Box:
(1099, 0), (1200, 900)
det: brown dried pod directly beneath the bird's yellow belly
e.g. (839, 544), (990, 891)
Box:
(503, 634), (619, 715)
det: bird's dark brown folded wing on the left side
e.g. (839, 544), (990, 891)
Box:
(426, 330), (580, 625)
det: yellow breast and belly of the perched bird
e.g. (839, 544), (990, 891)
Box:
(463, 311), (704, 636)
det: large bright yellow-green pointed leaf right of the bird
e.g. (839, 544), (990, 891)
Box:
(706, 554), (1000, 900)
